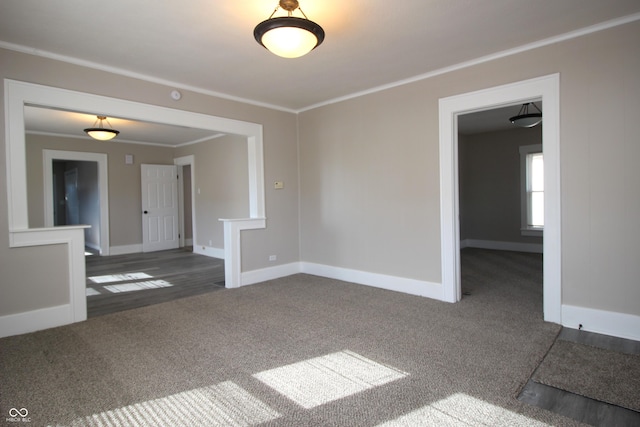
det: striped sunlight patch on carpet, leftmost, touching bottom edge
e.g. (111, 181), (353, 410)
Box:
(71, 381), (281, 427)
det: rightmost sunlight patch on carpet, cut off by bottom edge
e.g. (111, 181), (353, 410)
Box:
(377, 393), (547, 427)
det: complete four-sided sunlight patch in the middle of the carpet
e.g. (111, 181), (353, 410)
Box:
(254, 350), (409, 409)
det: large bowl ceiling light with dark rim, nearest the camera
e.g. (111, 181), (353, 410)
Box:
(253, 0), (324, 58)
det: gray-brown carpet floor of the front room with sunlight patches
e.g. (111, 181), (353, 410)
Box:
(0, 253), (578, 427)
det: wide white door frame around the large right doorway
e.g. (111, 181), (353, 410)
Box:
(439, 74), (562, 324)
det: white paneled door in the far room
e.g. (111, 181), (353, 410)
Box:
(141, 164), (179, 252)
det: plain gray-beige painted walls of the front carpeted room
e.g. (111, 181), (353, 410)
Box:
(0, 18), (640, 324)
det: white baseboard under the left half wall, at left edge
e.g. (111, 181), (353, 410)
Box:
(0, 304), (73, 338)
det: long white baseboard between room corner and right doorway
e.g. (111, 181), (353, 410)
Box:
(300, 262), (444, 301)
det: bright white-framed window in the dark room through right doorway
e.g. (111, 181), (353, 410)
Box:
(520, 144), (544, 236)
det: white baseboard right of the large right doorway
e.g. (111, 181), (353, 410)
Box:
(562, 305), (640, 341)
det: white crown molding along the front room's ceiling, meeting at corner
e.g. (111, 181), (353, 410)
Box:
(0, 13), (640, 114)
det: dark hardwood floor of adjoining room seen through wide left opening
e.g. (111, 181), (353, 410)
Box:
(85, 247), (224, 317)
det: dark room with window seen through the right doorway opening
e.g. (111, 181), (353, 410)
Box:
(457, 104), (543, 304)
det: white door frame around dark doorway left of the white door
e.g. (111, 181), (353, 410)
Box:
(42, 149), (110, 256)
